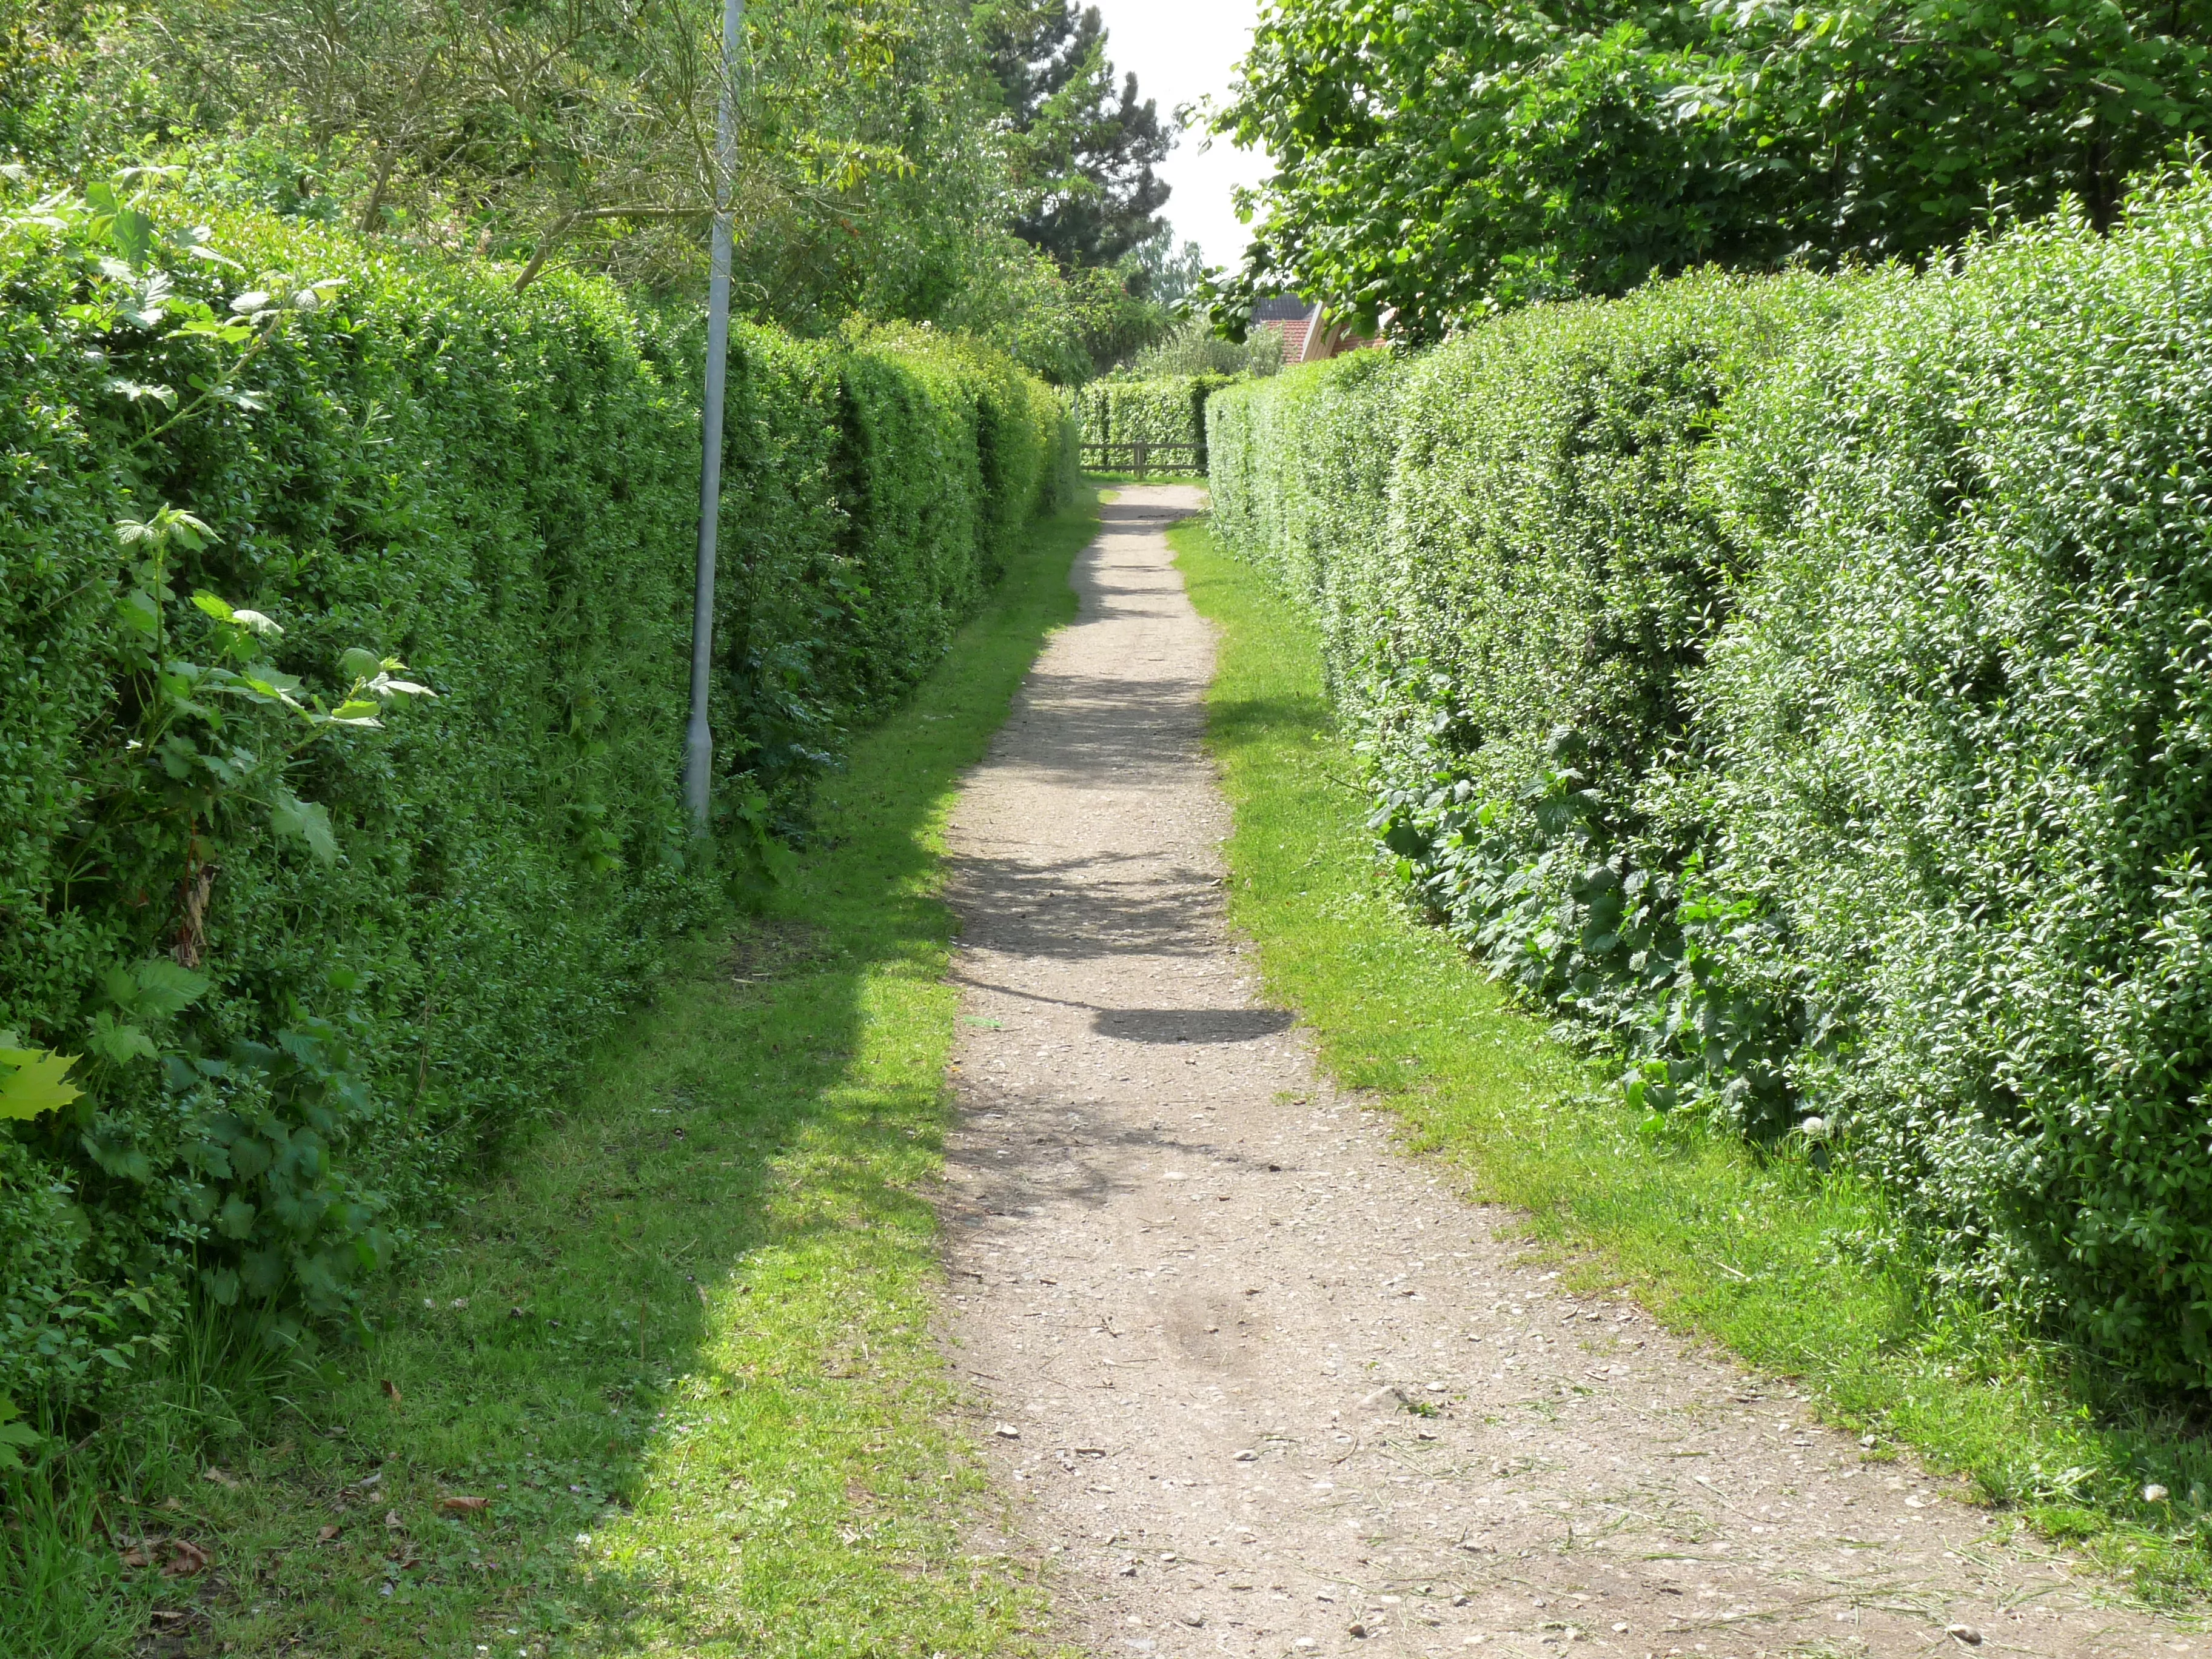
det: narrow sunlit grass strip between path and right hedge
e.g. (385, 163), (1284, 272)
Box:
(1170, 520), (2212, 1606)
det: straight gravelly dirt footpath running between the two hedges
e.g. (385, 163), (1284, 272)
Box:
(929, 487), (2212, 1659)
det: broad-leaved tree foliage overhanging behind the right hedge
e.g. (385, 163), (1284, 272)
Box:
(1215, 0), (2212, 343)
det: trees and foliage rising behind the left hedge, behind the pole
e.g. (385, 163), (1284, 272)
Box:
(0, 0), (1165, 385)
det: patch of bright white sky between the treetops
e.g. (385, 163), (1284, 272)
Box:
(1090, 0), (1267, 266)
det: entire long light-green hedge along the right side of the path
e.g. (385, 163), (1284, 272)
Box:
(1210, 181), (2212, 1392)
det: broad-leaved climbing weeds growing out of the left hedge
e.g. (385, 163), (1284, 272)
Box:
(0, 175), (434, 1365)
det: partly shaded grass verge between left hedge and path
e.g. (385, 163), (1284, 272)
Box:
(0, 497), (1097, 1659)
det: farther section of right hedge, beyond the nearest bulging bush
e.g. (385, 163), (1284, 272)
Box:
(1216, 274), (1840, 1133)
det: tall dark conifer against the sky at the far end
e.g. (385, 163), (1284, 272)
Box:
(980, 0), (1175, 266)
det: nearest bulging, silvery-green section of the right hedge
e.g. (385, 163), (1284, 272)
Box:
(1690, 181), (2212, 1389)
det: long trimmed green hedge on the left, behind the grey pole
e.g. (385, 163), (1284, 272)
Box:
(0, 186), (1073, 1403)
